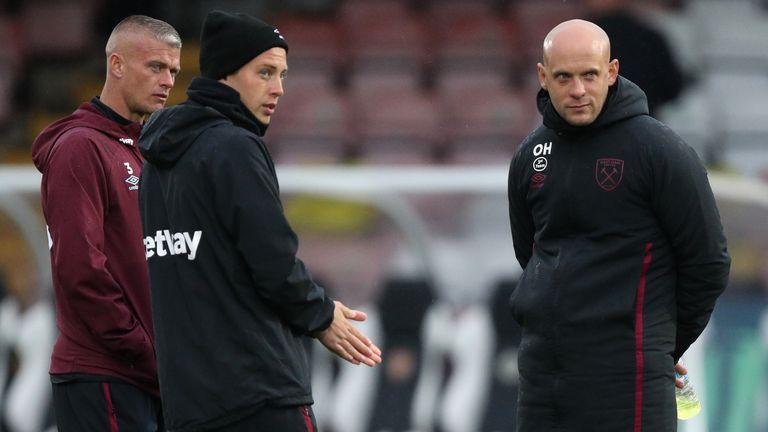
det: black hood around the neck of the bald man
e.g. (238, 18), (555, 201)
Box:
(537, 76), (648, 133)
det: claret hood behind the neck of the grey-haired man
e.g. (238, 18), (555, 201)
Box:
(32, 102), (141, 173)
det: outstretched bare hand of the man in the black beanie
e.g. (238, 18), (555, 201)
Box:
(317, 301), (381, 366)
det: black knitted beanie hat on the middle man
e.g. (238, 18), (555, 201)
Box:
(200, 10), (288, 80)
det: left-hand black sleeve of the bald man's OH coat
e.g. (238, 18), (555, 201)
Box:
(507, 151), (536, 269)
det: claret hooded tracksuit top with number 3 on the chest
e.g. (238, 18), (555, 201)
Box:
(32, 98), (158, 396)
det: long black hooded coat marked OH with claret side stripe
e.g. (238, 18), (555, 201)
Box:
(508, 77), (730, 432)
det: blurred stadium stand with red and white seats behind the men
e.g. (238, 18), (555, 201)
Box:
(0, 0), (768, 432)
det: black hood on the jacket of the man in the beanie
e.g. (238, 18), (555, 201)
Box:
(139, 77), (267, 166)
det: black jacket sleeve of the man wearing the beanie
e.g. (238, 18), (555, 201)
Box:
(212, 134), (334, 333)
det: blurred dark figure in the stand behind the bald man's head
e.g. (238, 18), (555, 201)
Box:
(585, 0), (685, 116)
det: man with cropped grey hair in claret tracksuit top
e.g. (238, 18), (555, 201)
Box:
(32, 15), (181, 432)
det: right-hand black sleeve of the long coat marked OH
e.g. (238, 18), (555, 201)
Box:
(652, 129), (731, 361)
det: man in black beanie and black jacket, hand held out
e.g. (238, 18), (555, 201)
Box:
(140, 11), (381, 432)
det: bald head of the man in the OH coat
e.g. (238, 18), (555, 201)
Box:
(536, 19), (619, 126)
